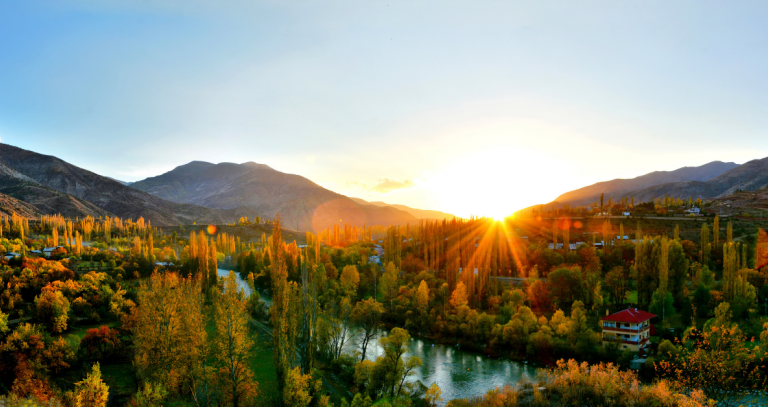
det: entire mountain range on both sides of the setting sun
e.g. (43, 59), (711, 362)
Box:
(0, 140), (768, 232)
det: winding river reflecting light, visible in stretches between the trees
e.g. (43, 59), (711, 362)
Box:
(218, 269), (539, 404)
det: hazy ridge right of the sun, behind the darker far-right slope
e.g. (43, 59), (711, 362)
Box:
(555, 161), (740, 206)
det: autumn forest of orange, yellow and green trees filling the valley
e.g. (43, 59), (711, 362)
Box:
(0, 200), (768, 407)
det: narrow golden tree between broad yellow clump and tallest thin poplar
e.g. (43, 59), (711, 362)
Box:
(212, 271), (257, 407)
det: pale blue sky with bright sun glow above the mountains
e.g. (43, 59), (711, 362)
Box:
(0, 0), (768, 217)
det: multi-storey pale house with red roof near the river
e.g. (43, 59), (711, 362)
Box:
(600, 308), (656, 352)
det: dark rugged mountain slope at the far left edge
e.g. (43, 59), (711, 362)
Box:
(0, 144), (255, 226)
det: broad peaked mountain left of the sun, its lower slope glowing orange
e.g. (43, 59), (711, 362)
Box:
(131, 161), (417, 232)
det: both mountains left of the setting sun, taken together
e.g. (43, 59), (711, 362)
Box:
(0, 144), (437, 231)
